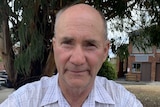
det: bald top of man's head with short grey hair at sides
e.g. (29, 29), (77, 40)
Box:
(55, 4), (107, 39)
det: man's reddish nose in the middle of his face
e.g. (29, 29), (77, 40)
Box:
(70, 46), (86, 65)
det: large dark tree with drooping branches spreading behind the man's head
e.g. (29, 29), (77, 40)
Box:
(0, 0), (160, 88)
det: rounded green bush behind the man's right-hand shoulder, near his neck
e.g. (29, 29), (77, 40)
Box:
(97, 60), (117, 80)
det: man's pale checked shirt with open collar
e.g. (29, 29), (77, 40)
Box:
(0, 74), (143, 107)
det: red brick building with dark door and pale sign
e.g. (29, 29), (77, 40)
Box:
(126, 30), (160, 81)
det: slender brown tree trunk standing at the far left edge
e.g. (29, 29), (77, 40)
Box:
(0, 0), (16, 82)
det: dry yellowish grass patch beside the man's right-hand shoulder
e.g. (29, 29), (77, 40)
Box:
(125, 85), (160, 107)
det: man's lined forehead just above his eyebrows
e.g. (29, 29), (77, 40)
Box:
(55, 18), (104, 41)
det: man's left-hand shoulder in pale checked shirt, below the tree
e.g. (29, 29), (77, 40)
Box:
(0, 76), (57, 107)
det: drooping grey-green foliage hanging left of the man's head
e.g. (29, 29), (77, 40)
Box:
(11, 0), (50, 76)
